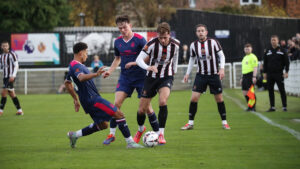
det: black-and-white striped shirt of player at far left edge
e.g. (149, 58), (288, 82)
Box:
(0, 51), (19, 78)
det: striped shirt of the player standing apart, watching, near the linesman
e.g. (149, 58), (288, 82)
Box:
(190, 38), (225, 75)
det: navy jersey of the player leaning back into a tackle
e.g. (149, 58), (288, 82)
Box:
(66, 60), (99, 113)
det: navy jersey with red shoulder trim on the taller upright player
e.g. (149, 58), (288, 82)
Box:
(114, 33), (147, 81)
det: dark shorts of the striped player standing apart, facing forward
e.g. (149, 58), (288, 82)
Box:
(193, 73), (222, 95)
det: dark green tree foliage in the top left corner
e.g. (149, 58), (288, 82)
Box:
(0, 0), (71, 32)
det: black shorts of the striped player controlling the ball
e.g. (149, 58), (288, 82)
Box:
(142, 76), (174, 98)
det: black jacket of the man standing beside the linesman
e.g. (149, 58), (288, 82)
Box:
(264, 46), (290, 73)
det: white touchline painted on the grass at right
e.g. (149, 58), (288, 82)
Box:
(223, 92), (300, 140)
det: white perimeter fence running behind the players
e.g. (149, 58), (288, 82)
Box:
(0, 61), (300, 96)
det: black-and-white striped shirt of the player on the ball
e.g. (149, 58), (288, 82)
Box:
(143, 38), (180, 78)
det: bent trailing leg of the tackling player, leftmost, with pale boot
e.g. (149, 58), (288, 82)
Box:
(67, 121), (108, 148)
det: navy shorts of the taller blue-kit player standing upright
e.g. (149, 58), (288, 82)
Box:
(116, 76), (145, 98)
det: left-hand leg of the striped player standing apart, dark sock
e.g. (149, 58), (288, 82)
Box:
(181, 91), (201, 130)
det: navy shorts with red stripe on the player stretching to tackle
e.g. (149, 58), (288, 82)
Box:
(88, 96), (118, 124)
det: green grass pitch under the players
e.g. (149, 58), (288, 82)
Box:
(0, 89), (300, 169)
